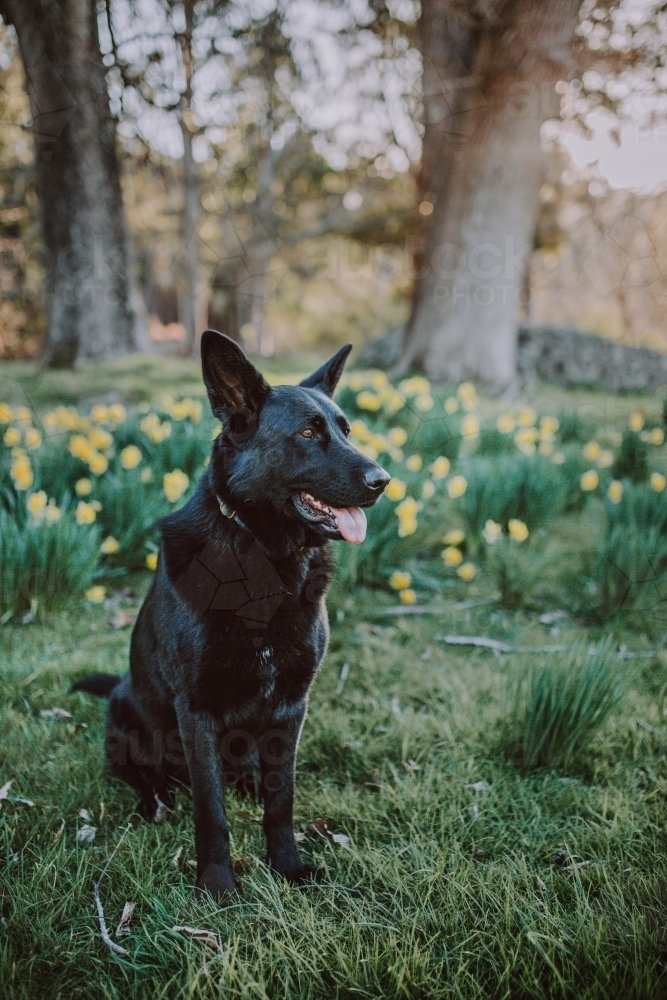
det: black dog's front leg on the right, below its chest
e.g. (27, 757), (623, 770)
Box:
(260, 709), (315, 884)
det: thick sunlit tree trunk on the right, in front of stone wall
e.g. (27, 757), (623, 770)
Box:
(398, 0), (580, 392)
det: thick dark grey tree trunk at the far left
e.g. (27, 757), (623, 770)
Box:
(0, 0), (135, 367)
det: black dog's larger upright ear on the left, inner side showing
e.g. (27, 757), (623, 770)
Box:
(201, 330), (271, 436)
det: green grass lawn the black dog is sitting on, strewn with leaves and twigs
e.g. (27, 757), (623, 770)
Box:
(0, 361), (667, 1000)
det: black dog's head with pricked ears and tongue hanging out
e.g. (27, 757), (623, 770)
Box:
(201, 330), (389, 543)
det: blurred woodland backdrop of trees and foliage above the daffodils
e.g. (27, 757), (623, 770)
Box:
(0, 0), (667, 390)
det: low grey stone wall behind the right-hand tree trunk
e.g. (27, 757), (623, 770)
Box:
(357, 326), (667, 392)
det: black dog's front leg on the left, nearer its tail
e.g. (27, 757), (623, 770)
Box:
(176, 704), (236, 897)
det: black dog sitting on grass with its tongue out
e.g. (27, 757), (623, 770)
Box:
(73, 330), (389, 896)
